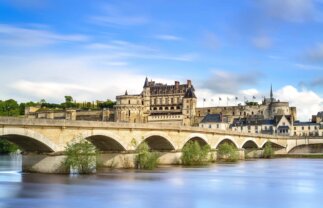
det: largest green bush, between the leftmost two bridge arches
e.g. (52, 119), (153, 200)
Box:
(64, 140), (98, 174)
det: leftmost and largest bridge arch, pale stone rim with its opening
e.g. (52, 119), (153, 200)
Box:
(0, 128), (59, 153)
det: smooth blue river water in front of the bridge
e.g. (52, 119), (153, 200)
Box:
(0, 156), (323, 208)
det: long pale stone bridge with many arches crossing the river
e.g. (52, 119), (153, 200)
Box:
(0, 117), (323, 172)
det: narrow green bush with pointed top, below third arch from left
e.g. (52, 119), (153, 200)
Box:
(135, 142), (159, 170)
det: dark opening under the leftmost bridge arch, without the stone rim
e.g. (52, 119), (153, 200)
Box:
(0, 134), (54, 153)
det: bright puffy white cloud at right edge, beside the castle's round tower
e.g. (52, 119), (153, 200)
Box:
(275, 85), (323, 121)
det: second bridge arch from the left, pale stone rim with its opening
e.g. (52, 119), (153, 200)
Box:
(80, 131), (127, 152)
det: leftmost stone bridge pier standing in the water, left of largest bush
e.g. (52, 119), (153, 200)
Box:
(22, 153), (66, 173)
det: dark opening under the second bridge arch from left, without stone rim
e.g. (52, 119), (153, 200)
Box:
(86, 135), (126, 152)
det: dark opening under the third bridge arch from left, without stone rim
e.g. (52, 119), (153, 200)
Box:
(143, 135), (175, 152)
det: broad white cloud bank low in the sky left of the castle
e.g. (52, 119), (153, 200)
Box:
(0, 55), (173, 102)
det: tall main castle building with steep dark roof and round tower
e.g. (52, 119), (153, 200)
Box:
(115, 78), (197, 125)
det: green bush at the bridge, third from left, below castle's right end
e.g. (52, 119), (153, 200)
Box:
(181, 141), (211, 165)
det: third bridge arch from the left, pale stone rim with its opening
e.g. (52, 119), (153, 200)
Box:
(138, 132), (176, 151)
